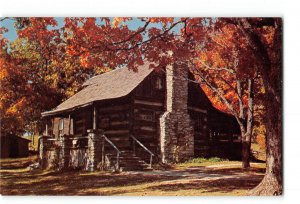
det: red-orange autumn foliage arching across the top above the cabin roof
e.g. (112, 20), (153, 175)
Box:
(0, 17), (271, 138)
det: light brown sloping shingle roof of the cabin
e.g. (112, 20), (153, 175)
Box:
(42, 63), (153, 116)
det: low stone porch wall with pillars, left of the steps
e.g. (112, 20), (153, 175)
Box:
(39, 134), (92, 171)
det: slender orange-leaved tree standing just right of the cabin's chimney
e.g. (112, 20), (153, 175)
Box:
(190, 20), (259, 168)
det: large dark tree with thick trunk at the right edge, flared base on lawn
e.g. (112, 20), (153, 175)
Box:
(236, 18), (283, 195)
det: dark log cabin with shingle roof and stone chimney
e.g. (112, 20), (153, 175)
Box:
(40, 62), (241, 171)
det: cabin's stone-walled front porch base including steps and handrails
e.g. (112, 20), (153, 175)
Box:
(39, 129), (155, 171)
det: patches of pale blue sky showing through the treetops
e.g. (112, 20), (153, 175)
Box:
(1, 17), (169, 41)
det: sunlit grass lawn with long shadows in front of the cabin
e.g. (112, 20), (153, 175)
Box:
(0, 156), (265, 196)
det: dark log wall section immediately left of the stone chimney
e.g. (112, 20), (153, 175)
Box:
(131, 72), (166, 160)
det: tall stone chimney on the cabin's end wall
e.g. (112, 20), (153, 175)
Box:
(160, 62), (194, 163)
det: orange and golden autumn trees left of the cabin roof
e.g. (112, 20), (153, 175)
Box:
(0, 18), (101, 134)
